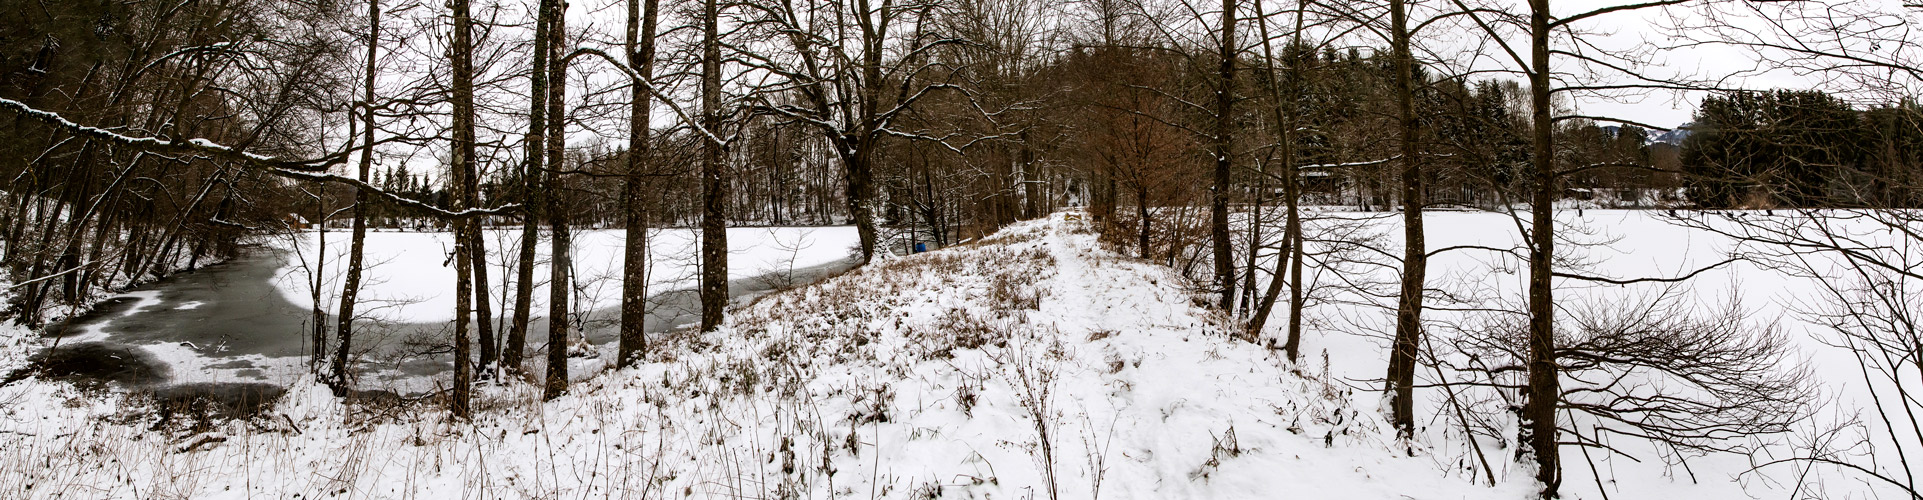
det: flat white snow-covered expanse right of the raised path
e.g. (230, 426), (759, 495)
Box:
(1263, 210), (1923, 498)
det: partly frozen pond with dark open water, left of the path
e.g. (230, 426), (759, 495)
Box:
(33, 227), (854, 392)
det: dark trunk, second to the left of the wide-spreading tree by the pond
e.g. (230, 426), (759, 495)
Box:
(630, 0), (660, 367)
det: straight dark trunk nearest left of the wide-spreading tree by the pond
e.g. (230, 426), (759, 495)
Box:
(700, 0), (723, 331)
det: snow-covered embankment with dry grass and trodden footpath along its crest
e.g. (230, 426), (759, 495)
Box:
(0, 215), (1529, 498)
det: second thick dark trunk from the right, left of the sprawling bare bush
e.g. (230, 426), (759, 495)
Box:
(1386, 0), (1429, 438)
